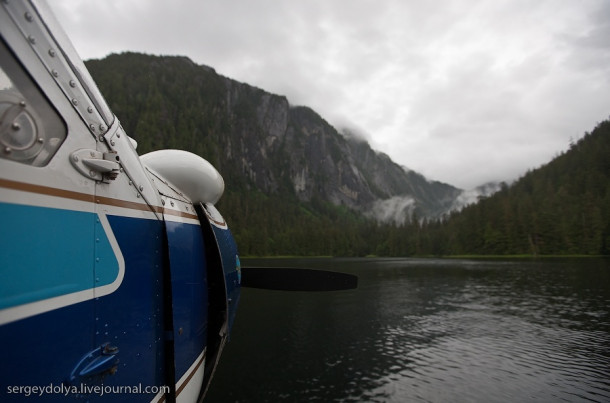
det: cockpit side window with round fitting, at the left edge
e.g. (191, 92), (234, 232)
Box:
(0, 41), (66, 166)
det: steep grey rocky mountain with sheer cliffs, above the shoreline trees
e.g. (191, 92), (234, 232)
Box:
(87, 53), (461, 222)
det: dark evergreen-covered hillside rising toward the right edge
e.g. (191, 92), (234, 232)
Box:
(405, 120), (610, 255)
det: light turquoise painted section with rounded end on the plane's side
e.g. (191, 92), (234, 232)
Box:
(0, 203), (119, 309)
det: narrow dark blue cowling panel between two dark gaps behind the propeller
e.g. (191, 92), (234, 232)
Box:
(165, 221), (208, 380)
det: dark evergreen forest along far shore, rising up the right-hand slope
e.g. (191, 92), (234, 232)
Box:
(227, 120), (610, 256)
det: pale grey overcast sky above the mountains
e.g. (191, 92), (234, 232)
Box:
(51, 0), (610, 188)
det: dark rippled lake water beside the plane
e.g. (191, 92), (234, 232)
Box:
(206, 259), (610, 403)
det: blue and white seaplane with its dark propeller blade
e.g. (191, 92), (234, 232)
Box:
(0, 0), (357, 402)
